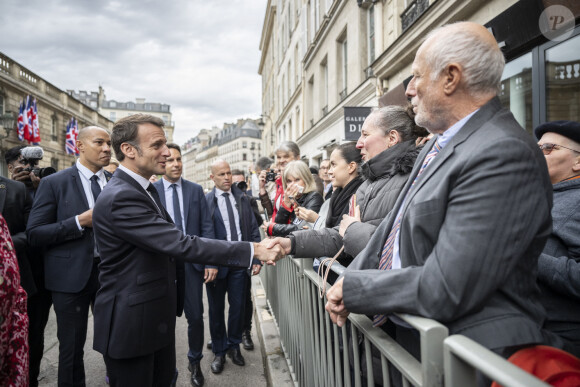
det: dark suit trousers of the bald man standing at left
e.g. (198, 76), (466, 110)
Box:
(52, 260), (99, 387)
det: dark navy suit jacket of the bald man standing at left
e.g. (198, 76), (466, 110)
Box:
(26, 165), (111, 293)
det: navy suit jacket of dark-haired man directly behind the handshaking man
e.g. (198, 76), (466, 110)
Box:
(153, 178), (217, 316)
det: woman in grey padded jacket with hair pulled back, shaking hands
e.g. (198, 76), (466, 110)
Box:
(272, 106), (428, 264)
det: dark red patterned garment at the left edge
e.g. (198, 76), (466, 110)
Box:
(0, 215), (28, 387)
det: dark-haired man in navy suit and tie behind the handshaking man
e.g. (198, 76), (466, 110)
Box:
(153, 144), (218, 387)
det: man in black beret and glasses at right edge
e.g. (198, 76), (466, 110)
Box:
(535, 121), (580, 357)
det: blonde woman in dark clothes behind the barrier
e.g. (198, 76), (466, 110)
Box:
(265, 160), (324, 236)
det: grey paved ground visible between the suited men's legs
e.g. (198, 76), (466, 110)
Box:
(39, 277), (270, 387)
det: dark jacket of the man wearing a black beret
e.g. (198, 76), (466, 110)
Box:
(538, 179), (580, 356)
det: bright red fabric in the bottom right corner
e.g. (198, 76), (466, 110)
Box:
(492, 345), (580, 387)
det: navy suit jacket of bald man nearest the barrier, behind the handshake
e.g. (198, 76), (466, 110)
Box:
(205, 186), (262, 279)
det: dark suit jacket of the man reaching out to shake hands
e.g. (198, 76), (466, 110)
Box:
(93, 169), (251, 359)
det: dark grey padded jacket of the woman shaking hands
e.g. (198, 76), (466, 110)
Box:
(292, 140), (421, 258)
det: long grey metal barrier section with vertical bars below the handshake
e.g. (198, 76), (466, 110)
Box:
(262, 259), (448, 387)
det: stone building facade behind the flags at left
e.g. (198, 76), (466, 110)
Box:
(0, 52), (113, 176)
